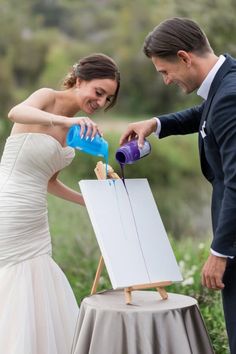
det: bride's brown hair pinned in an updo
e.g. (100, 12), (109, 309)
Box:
(63, 53), (120, 111)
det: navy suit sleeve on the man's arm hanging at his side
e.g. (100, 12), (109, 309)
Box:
(212, 93), (236, 256)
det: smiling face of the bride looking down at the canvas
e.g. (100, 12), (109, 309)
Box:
(76, 79), (117, 114)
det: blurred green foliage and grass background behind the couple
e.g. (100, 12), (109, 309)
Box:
(0, 0), (236, 354)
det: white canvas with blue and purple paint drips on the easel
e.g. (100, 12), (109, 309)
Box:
(79, 179), (182, 289)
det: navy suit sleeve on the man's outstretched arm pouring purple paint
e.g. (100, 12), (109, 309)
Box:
(158, 103), (204, 139)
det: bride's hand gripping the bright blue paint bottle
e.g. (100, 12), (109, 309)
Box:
(65, 117), (103, 139)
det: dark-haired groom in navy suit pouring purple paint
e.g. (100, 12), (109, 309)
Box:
(120, 18), (236, 354)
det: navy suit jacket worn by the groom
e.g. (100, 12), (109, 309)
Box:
(158, 55), (236, 256)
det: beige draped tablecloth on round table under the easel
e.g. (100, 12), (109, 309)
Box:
(72, 291), (214, 354)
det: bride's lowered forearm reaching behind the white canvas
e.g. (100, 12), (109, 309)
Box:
(48, 174), (85, 205)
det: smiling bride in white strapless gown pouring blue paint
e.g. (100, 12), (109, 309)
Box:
(0, 54), (120, 354)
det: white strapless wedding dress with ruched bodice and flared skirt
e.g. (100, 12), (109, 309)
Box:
(0, 133), (78, 354)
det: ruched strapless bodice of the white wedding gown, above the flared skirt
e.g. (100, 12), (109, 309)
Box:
(0, 133), (74, 267)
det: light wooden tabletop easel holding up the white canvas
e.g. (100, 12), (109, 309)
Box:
(91, 161), (172, 304)
